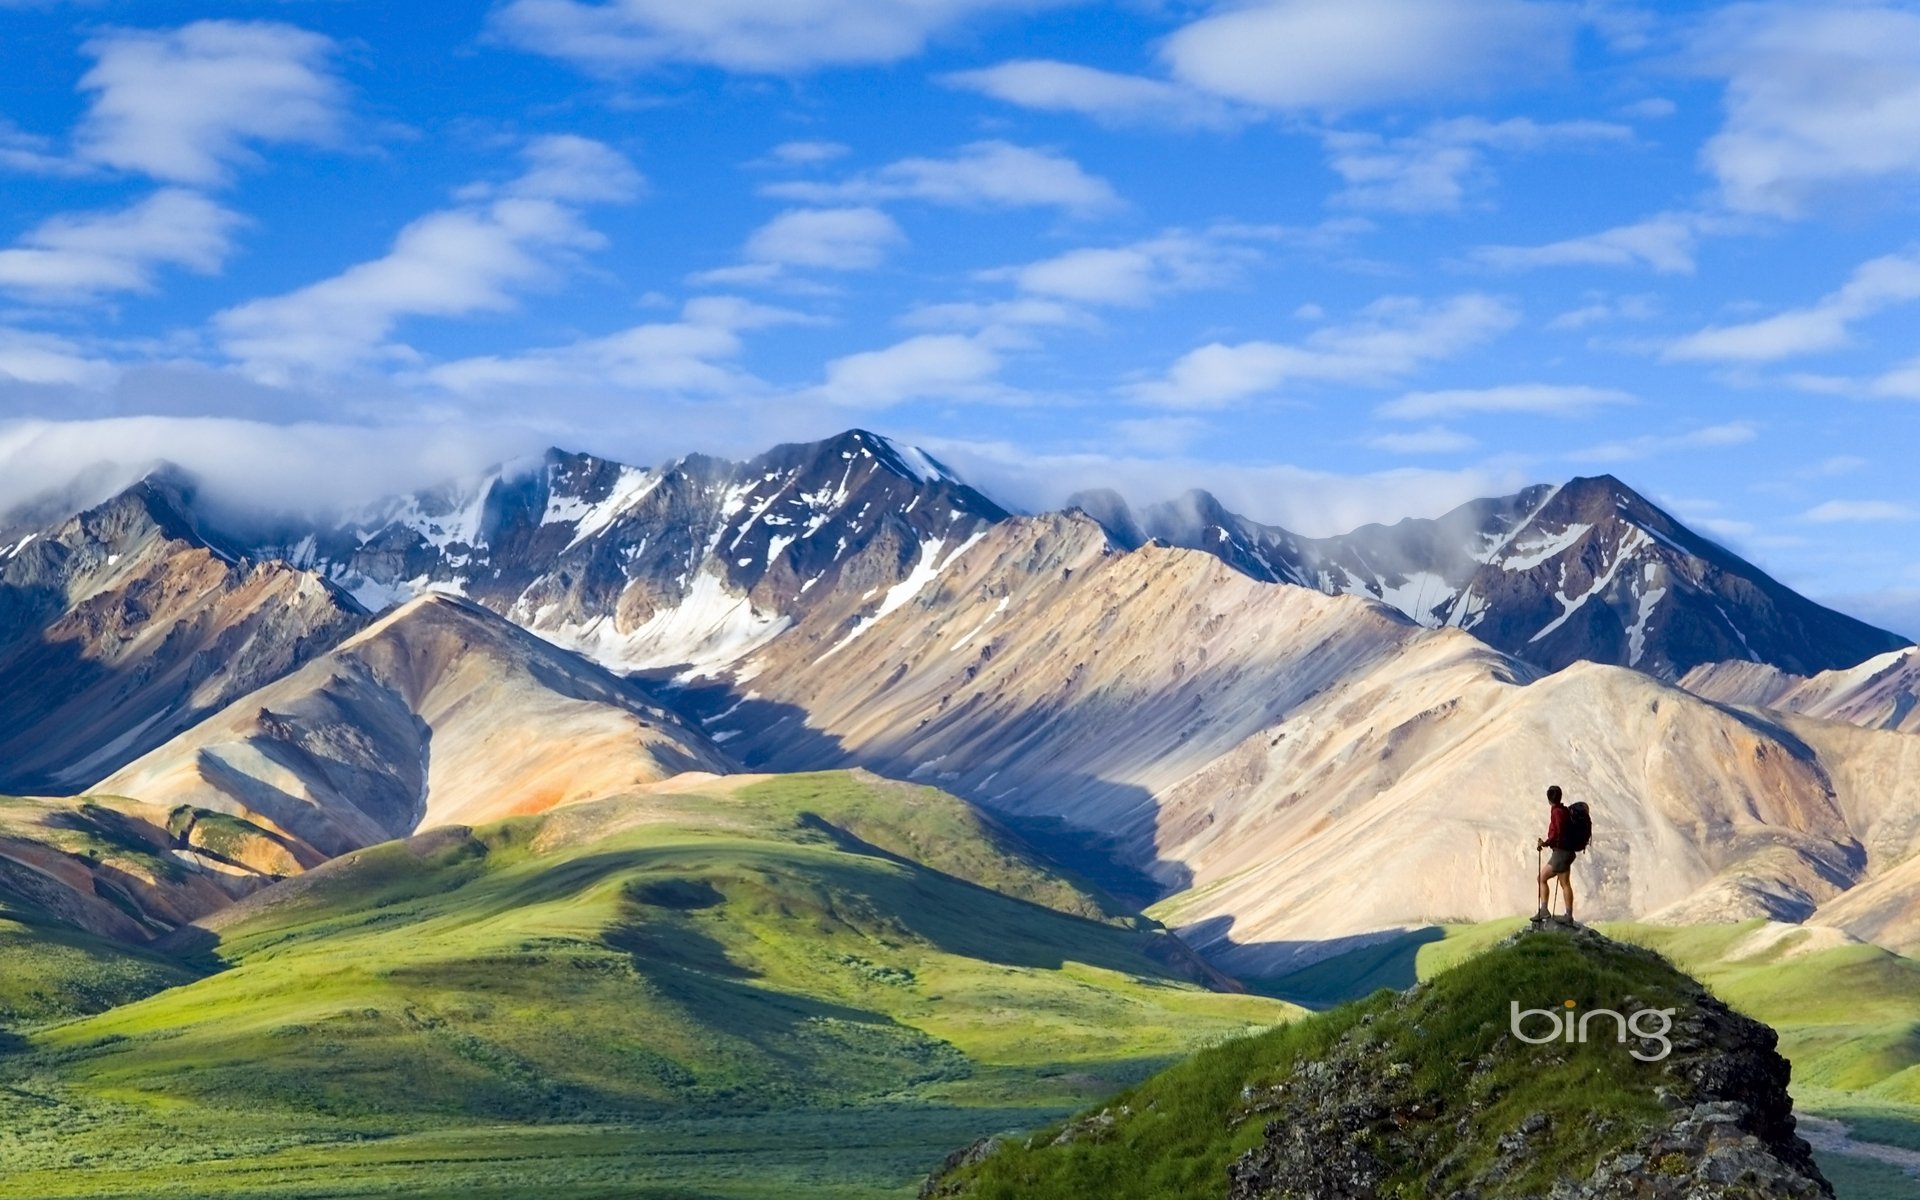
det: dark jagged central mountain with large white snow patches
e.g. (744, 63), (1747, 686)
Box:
(243, 430), (1006, 674)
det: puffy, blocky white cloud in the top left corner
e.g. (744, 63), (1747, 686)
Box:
(75, 21), (342, 184)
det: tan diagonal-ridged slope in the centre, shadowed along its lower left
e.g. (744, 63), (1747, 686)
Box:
(725, 513), (1443, 860)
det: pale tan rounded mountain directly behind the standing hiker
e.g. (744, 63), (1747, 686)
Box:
(1156, 662), (1920, 973)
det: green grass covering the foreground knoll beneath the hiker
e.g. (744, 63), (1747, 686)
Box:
(948, 937), (1720, 1200)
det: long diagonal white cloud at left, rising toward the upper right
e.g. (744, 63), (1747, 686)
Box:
(215, 140), (637, 382)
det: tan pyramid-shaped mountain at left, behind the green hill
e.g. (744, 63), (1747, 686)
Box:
(100, 595), (728, 856)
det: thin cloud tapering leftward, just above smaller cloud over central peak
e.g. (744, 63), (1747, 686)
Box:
(762, 142), (1119, 213)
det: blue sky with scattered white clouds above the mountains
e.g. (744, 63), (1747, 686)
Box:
(0, 0), (1920, 636)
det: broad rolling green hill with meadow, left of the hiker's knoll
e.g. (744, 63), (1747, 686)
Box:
(0, 772), (1296, 1196)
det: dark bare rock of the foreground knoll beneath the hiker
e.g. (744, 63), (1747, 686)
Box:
(1227, 929), (1834, 1200)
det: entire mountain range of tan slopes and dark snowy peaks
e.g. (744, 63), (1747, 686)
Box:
(0, 430), (1920, 975)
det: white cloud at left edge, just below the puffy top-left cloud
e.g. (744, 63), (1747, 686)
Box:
(0, 188), (240, 301)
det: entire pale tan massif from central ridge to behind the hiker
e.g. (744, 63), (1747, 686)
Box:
(712, 515), (1920, 973)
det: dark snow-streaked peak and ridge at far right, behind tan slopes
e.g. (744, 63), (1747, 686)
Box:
(1077, 476), (1907, 680)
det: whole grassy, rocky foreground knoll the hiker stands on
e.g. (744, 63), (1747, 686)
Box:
(922, 931), (1834, 1200)
